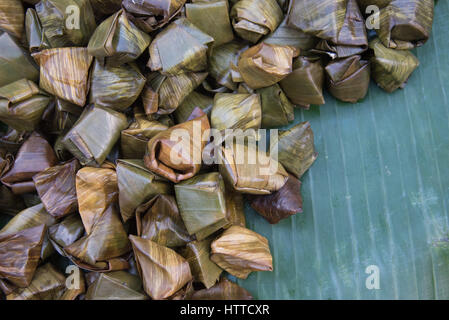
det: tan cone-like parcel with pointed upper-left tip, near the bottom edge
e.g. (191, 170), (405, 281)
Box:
(129, 235), (192, 300)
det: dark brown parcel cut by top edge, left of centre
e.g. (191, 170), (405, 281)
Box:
(122, 0), (186, 33)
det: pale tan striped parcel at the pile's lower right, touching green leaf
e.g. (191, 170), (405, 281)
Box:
(210, 226), (273, 279)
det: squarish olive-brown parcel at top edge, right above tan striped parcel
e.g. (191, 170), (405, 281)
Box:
(35, 0), (97, 48)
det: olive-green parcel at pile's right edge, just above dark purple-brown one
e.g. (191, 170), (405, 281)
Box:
(270, 121), (318, 179)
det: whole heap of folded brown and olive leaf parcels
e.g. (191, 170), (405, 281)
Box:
(0, 0), (434, 299)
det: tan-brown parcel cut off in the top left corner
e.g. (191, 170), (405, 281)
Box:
(0, 0), (25, 39)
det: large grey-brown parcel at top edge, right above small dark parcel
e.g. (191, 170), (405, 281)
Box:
(287, 0), (368, 59)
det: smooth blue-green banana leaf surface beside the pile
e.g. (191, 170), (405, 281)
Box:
(239, 1), (449, 299)
